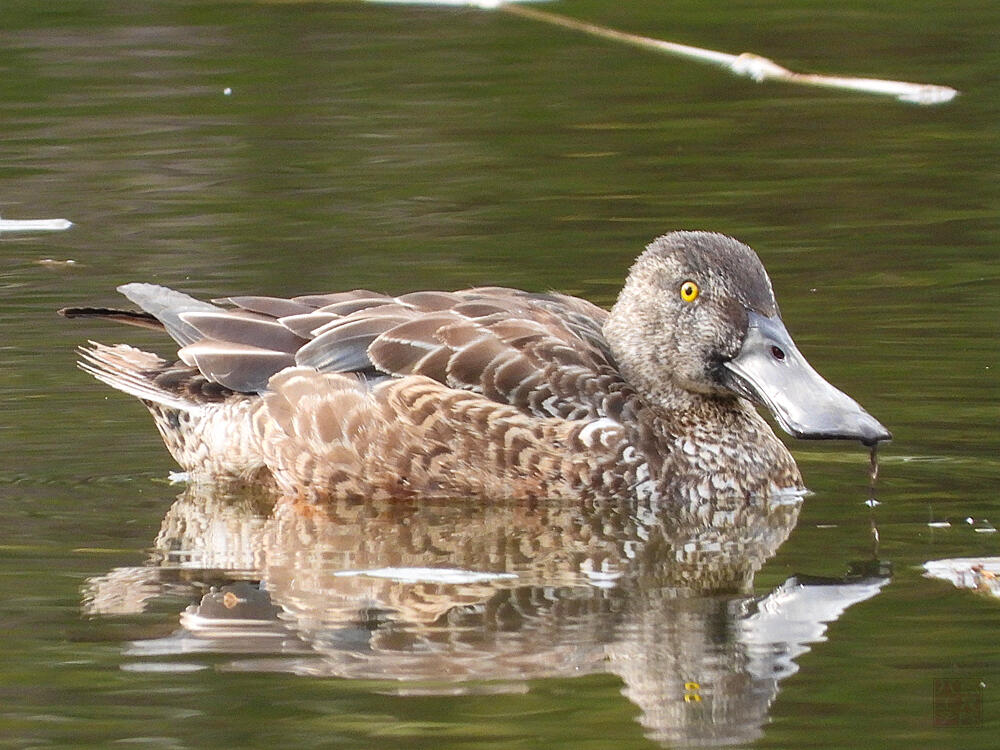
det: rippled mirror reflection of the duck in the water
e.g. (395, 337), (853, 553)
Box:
(85, 488), (888, 745)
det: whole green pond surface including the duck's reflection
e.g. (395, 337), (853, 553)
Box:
(0, 0), (1000, 748)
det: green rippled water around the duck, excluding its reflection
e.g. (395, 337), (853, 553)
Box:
(0, 0), (1000, 748)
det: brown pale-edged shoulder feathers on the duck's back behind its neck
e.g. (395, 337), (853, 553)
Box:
(296, 287), (627, 419)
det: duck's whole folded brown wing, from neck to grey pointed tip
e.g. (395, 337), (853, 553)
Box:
(103, 284), (629, 419)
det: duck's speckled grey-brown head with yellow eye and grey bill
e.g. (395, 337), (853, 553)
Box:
(605, 232), (892, 445)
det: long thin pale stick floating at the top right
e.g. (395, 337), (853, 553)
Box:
(368, 0), (958, 104)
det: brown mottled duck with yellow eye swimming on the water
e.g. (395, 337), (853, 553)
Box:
(60, 231), (892, 506)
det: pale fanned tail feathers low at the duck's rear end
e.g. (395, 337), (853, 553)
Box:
(78, 341), (200, 411)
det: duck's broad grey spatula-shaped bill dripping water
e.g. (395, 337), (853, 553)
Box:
(723, 312), (892, 445)
